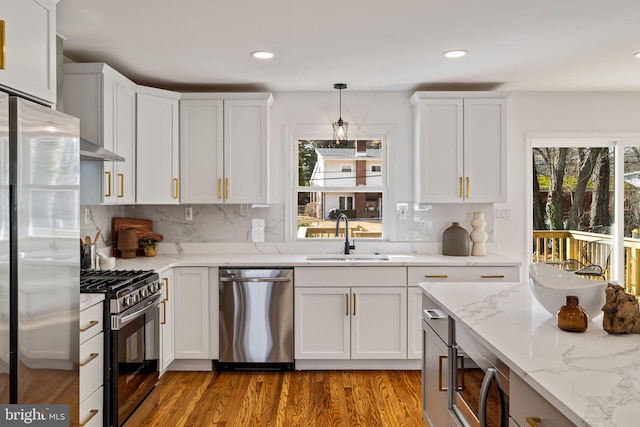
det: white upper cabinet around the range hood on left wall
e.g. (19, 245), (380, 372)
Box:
(63, 63), (136, 204)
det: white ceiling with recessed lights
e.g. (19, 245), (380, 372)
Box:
(57, 0), (640, 92)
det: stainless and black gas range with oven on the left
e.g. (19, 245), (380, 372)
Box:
(80, 270), (162, 427)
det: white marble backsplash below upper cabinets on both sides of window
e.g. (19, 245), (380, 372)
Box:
(81, 202), (494, 251)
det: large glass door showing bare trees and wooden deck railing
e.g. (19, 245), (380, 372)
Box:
(532, 142), (640, 295)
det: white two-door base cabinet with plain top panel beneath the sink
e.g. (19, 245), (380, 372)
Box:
(294, 267), (407, 360)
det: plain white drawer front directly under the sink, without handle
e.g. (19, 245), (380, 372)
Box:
(295, 266), (407, 287)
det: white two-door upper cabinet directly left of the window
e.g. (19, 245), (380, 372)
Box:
(180, 93), (273, 204)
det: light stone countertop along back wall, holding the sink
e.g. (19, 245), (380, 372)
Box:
(97, 252), (522, 272)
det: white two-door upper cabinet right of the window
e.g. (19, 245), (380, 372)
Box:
(410, 92), (506, 203)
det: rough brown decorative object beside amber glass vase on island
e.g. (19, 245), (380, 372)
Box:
(602, 283), (640, 334)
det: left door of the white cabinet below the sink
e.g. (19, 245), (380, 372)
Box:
(294, 288), (351, 359)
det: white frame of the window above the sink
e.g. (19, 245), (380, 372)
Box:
(285, 124), (395, 244)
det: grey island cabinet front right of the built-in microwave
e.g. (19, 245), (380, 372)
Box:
(509, 371), (575, 427)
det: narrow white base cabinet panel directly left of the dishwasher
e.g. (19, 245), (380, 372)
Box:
(173, 267), (210, 359)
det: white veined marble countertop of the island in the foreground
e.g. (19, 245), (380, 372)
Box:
(420, 283), (640, 427)
